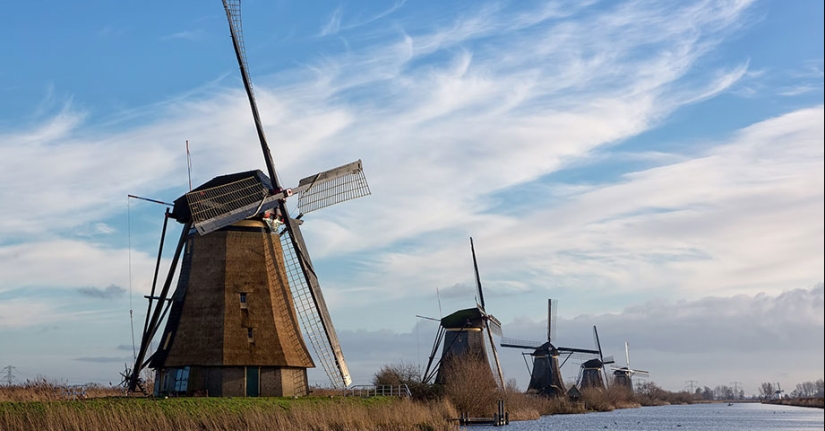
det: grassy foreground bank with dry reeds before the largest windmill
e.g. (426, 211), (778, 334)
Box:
(0, 397), (458, 431)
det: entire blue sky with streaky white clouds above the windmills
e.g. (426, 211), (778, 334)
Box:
(0, 0), (825, 393)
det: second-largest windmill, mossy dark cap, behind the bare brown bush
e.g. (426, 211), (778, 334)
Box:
(422, 238), (504, 388)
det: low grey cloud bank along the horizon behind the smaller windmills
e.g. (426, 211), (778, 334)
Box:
(326, 284), (825, 395)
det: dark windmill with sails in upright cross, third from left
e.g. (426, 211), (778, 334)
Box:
(501, 299), (599, 397)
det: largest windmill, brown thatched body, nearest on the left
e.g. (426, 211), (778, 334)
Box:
(128, 0), (370, 396)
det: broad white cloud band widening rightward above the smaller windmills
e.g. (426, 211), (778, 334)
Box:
(336, 107), (823, 312)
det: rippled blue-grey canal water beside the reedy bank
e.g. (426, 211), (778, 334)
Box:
(466, 403), (825, 431)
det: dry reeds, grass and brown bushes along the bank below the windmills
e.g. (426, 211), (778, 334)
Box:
(6, 361), (808, 431)
